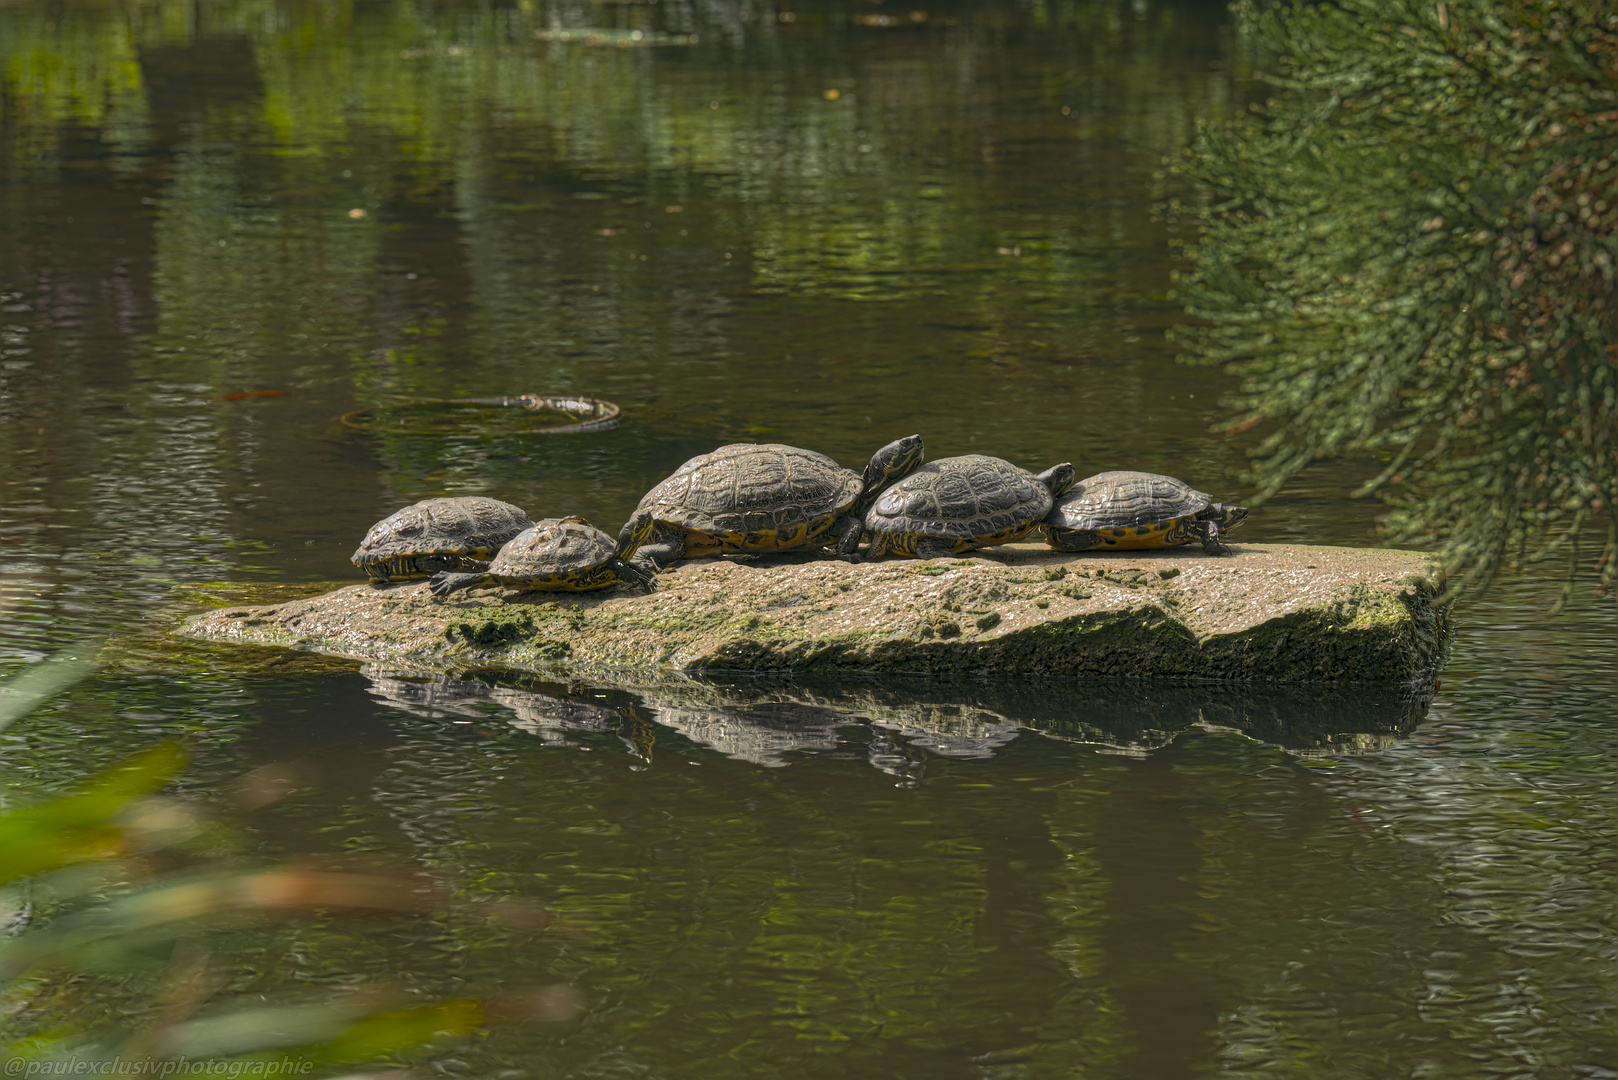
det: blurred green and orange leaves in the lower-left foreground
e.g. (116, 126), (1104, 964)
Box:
(0, 661), (579, 1077)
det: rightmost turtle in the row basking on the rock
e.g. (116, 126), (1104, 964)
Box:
(1045, 471), (1247, 555)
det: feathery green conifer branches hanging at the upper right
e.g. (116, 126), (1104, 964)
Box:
(1170, 0), (1618, 591)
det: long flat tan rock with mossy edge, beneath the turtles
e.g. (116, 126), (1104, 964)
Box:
(181, 544), (1445, 685)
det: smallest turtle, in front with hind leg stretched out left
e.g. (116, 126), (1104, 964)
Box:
(427, 513), (657, 596)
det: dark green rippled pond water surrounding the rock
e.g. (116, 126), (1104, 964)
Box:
(0, 0), (1618, 1080)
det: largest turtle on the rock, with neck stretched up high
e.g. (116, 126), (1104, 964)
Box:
(625, 436), (925, 567)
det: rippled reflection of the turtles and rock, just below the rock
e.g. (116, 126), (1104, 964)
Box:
(364, 665), (1430, 764)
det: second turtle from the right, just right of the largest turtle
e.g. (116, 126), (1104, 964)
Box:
(864, 453), (1073, 559)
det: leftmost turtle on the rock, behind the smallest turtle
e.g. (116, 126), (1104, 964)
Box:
(353, 495), (534, 583)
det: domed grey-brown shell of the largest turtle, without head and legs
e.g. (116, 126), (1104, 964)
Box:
(636, 442), (864, 555)
